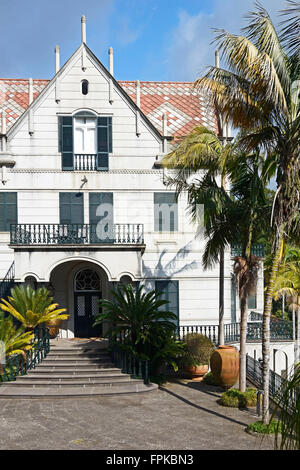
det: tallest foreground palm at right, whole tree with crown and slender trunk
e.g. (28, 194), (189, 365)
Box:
(195, 0), (300, 424)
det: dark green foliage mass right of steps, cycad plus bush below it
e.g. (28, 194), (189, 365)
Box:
(95, 284), (184, 374)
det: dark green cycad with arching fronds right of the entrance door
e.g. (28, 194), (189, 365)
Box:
(94, 284), (177, 358)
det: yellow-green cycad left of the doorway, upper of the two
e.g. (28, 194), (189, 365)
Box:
(0, 285), (69, 330)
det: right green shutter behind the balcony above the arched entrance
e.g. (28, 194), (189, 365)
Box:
(89, 193), (114, 243)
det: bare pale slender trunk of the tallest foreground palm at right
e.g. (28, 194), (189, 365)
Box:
(262, 234), (283, 424)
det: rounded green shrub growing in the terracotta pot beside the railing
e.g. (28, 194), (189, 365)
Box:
(183, 333), (216, 366)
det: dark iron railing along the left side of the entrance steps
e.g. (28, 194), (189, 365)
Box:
(0, 327), (50, 382)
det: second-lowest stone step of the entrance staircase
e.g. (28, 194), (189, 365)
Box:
(0, 377), (143, 392)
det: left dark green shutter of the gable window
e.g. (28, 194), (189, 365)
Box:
(59, 116), (74, 171)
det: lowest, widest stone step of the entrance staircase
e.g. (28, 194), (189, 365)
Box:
(0, 382), (158, 399)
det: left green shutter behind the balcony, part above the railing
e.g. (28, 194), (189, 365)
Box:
(59, 193), (83, 224)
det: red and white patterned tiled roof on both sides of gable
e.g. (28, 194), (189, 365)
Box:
(0, 78), (218, 137)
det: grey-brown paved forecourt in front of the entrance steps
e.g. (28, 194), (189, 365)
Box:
(0, 381), (272, 450)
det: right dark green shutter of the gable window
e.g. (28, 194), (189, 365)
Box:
(97, 116), (112, 171)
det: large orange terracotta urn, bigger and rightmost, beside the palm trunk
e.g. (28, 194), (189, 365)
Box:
(210, 345), (239, 389)
